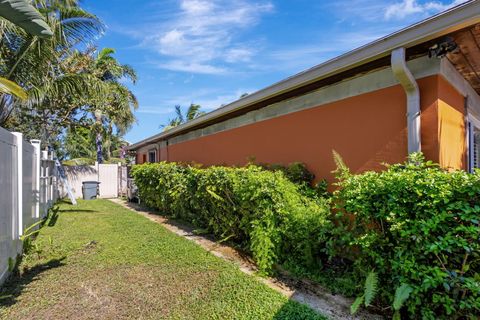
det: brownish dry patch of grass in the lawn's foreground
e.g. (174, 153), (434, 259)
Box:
(1, 265), (217, 320)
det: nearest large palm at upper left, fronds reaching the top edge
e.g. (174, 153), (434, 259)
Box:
(0, 0), (103, 131)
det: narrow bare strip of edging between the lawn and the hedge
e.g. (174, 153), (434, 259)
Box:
(111, 199), (383, 320)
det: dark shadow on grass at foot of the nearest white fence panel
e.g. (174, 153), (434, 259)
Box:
(0, 257), (65, 307)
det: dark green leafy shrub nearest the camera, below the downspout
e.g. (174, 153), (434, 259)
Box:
(333, 154), (480, 319)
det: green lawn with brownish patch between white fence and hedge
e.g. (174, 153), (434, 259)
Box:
(0, 200), (324, 319)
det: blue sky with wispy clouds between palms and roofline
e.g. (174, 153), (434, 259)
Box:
(83, 0), (464, 142)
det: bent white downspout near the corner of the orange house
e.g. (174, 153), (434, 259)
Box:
(391, 48), (422, 154)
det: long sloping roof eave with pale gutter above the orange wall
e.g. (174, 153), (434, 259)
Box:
(129, 0), (480, 150)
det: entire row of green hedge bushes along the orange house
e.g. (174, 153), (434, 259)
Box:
(132, 154), (480, 319)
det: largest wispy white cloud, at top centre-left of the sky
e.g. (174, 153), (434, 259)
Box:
(143, 0), (273, 74)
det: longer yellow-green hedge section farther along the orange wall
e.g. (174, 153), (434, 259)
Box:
(132, 162), (331, 272)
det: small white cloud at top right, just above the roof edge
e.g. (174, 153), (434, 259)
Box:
(385, 0), (465, 20)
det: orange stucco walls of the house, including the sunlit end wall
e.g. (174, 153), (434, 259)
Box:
(134, 76), (465, 181)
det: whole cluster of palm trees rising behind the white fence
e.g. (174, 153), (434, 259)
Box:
(0, 0), (138, 162)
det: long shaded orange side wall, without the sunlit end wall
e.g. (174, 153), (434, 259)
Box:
(164, 77), (436, 180)
